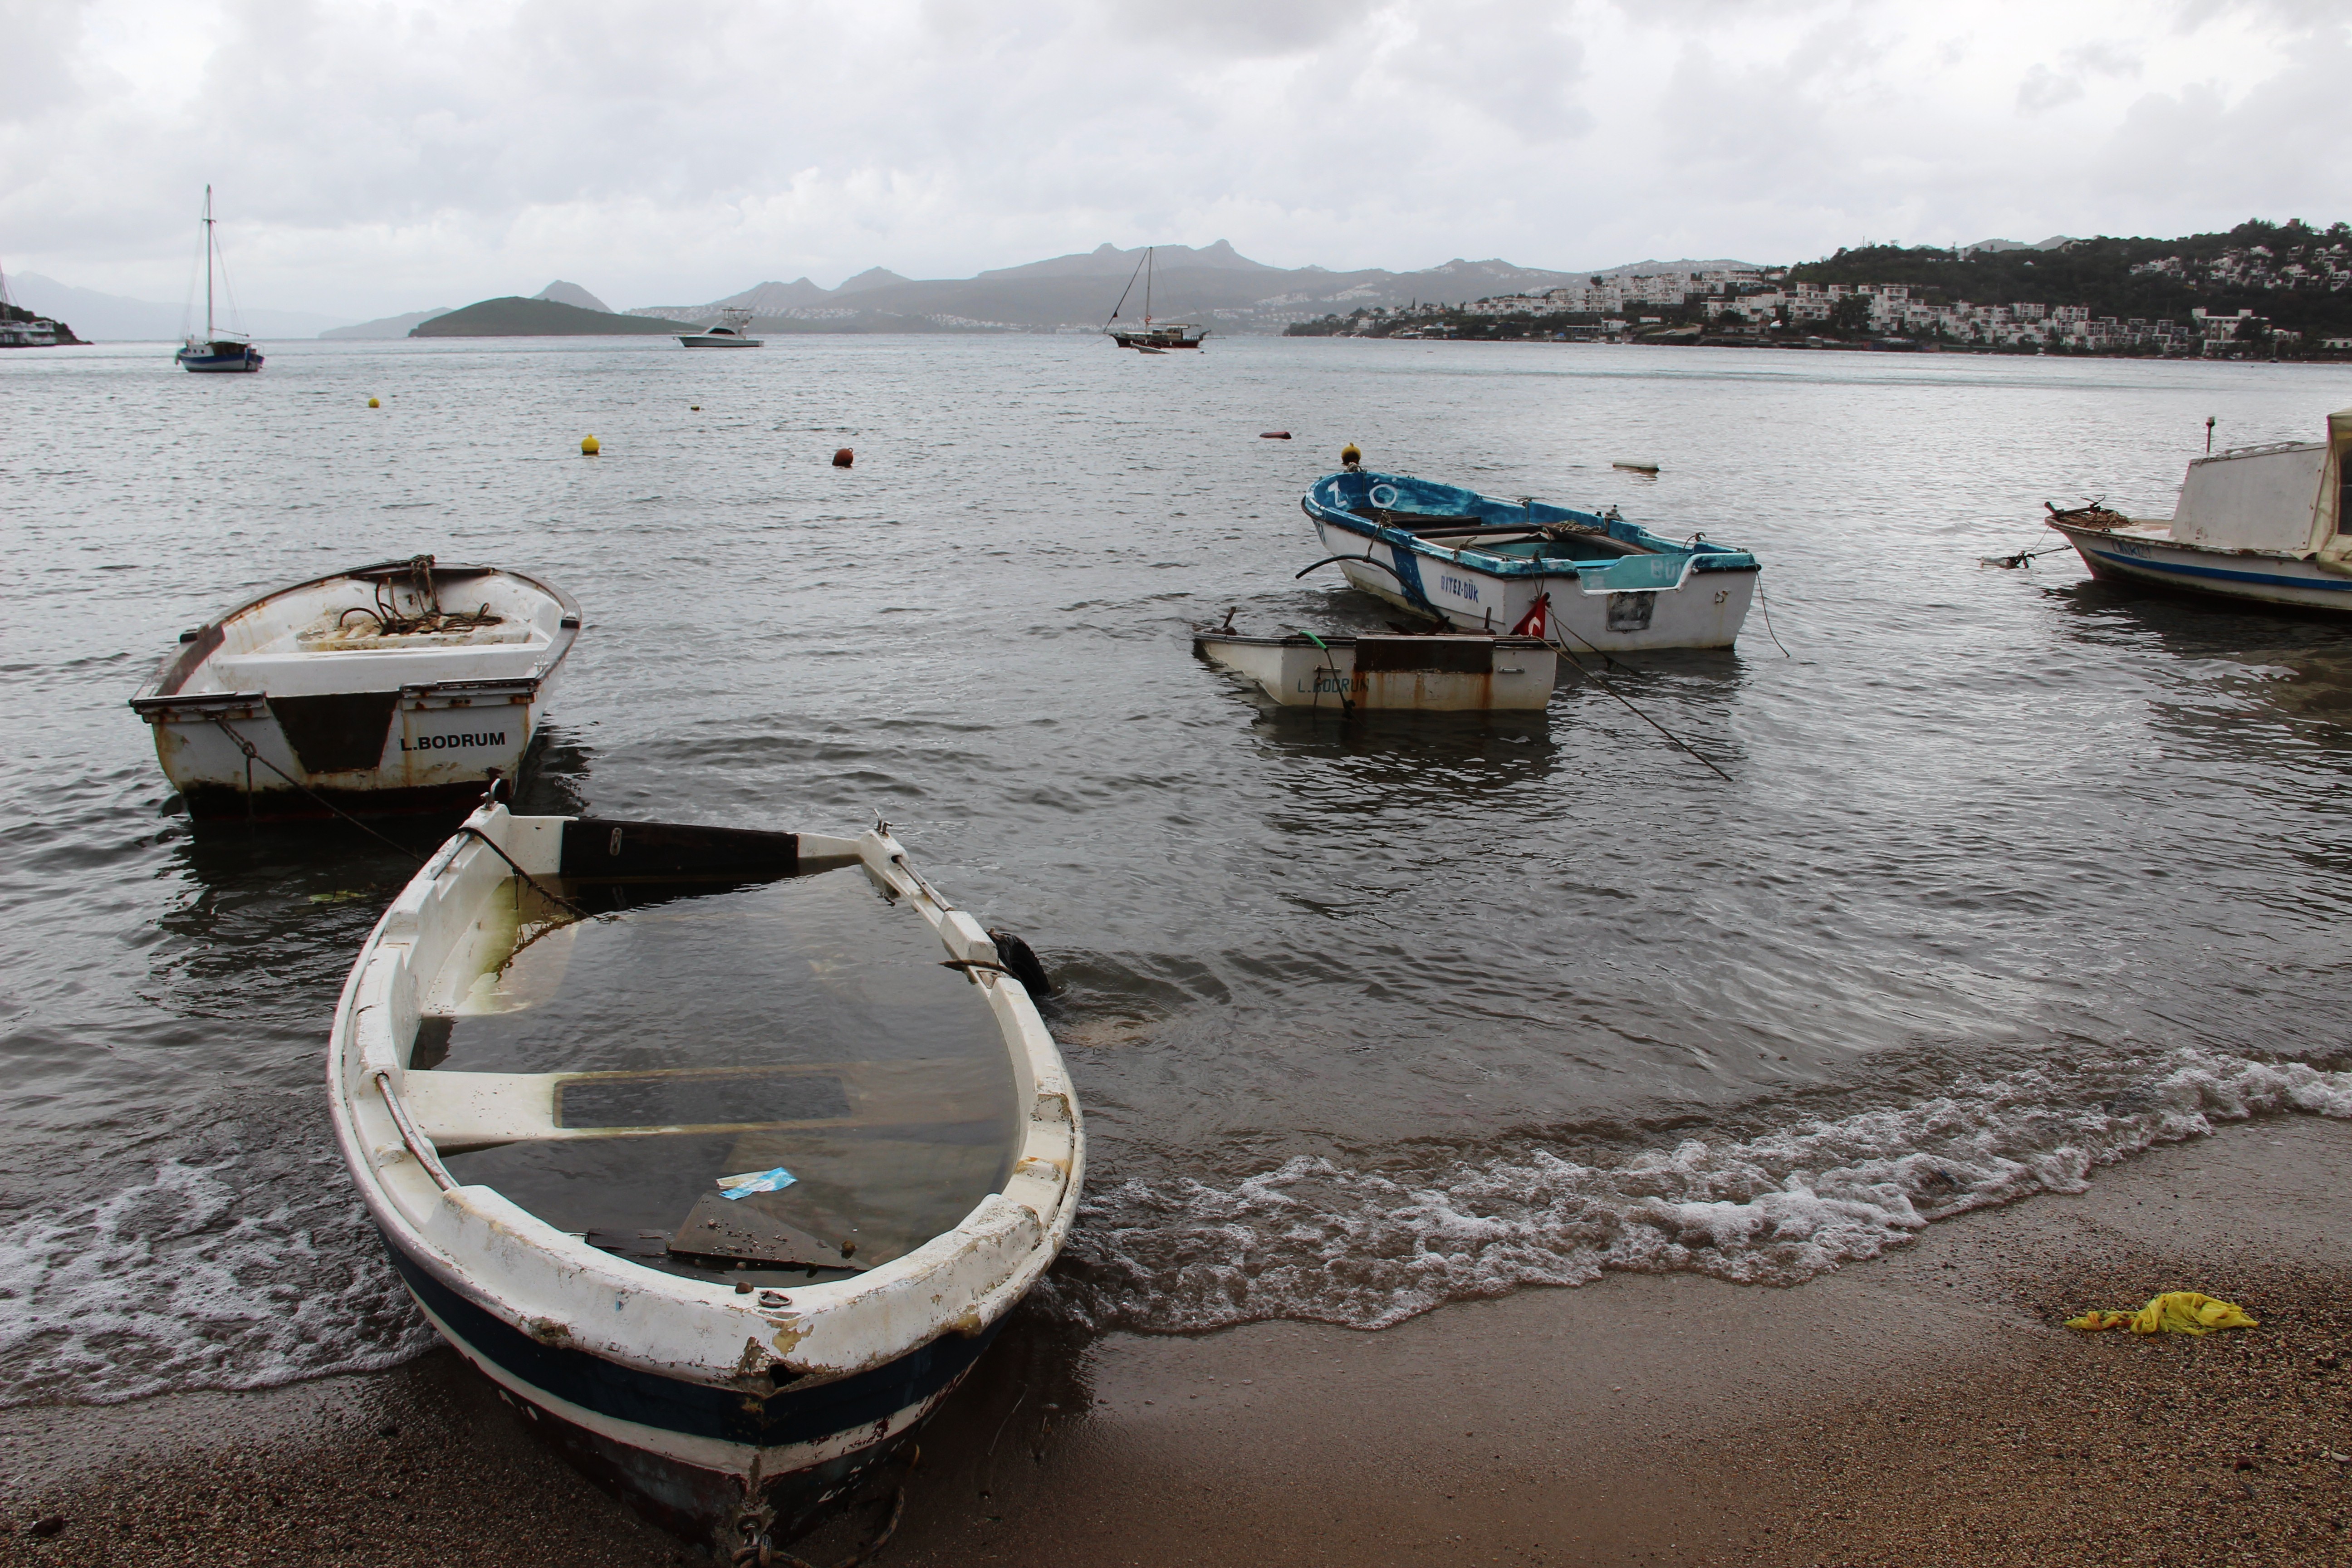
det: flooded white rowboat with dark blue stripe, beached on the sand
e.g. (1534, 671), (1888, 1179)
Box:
(327, 804), (1084, 1563)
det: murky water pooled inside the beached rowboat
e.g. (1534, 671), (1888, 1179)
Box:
(428, 863), (1019, 1286)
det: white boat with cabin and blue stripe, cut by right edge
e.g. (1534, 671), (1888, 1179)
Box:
(2048, 409), (2352, 611)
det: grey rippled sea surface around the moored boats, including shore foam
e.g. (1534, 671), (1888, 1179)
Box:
(0, 338), (2352, 1403)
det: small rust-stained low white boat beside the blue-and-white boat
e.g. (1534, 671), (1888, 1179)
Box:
(1192, 630), (1559, 712)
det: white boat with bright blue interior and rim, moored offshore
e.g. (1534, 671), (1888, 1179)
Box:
(1301, 470), (1759, 653)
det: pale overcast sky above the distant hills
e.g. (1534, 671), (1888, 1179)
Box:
(0, 0), (2352, 317)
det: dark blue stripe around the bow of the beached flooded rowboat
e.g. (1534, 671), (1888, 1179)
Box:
(383, 1236), (1002, 1448)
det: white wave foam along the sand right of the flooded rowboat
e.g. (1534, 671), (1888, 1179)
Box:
(1042, 1049), (2352, 1333)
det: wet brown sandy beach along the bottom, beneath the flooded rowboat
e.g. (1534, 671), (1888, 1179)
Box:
(0, 1117), (2352, 1568)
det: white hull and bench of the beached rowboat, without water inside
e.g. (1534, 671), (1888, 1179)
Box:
(327, 804), (1084, 1563)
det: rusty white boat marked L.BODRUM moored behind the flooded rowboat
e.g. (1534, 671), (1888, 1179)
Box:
(132, 555), (581, 818)
